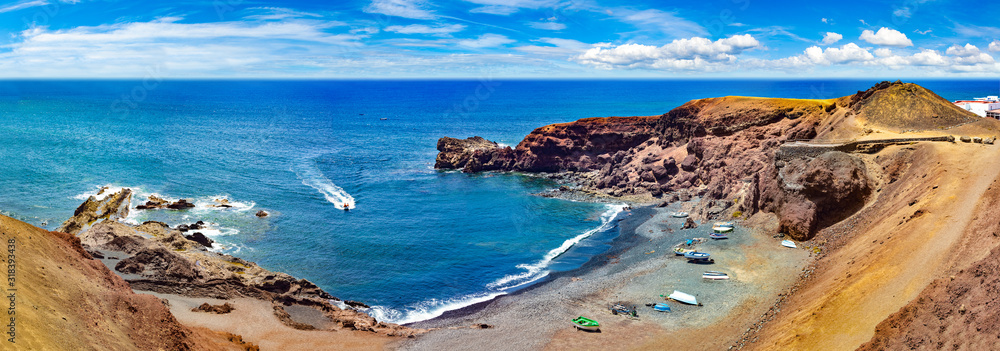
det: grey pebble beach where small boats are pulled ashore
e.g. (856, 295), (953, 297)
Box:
(399, 208), (811, 350)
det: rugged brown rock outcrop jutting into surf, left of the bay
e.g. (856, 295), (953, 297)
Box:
(69, 189), (422, 336)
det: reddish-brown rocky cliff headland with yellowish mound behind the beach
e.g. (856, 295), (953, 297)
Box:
(436, 82), (975, 239)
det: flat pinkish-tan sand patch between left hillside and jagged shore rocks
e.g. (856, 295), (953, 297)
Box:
(143, 291), (394, 350)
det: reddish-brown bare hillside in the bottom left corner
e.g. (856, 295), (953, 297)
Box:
(0, 216), (242, 350)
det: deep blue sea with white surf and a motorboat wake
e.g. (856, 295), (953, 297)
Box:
(0, 80), (1000, 322)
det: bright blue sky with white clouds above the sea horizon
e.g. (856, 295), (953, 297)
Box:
(0, 0), (1000, 78)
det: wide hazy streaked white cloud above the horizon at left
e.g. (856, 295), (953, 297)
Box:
(0, 18), (364, 77)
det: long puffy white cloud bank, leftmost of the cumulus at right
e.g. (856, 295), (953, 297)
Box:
(574, 34), (760, 70)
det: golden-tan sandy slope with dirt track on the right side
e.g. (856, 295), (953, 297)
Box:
(753, 131), (1000, 350)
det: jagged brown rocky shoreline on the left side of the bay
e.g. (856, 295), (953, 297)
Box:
(60, 189), (422, 337)
